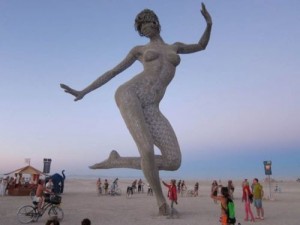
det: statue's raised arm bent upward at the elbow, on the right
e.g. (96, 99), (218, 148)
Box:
(174, 3), (212, 54)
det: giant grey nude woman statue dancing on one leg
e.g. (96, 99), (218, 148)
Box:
(60, 3), (212, 215)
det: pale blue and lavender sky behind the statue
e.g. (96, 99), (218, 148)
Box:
(0, 0), (300, 179)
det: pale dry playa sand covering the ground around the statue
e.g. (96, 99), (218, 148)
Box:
(0, 179), (300, 225)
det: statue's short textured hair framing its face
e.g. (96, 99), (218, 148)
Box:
(134, 9), (160, 36)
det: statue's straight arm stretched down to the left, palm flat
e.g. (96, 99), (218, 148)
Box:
(60, 47), (138, 101)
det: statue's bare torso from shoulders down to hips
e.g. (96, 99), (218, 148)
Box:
(120, 44), (180, 105)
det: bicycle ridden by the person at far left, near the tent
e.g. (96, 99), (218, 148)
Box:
(17, 195), (64, 223)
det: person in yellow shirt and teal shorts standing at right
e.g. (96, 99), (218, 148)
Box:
(253, 178), (265, 220)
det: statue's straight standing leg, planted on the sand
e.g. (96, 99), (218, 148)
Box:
(116, 88), (181, 214)
